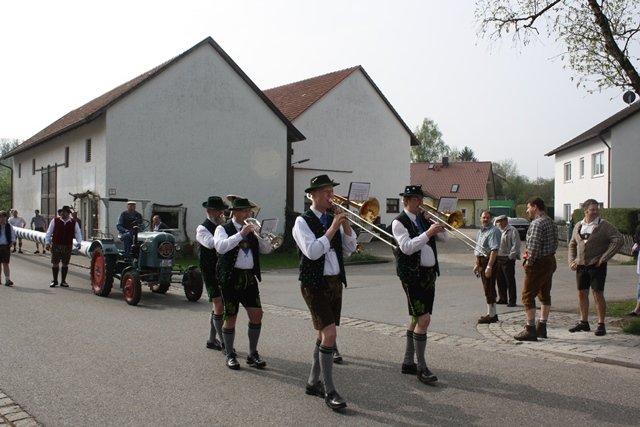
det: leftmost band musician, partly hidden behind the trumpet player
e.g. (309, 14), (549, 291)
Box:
(196, 196), (229, 350)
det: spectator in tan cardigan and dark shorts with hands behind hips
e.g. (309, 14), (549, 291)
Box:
(568, 199), (623, 337)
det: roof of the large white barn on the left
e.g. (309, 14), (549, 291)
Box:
(2, 37), (305, 158)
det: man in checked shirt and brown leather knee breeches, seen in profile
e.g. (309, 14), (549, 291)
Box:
(513, 197), (558, 341)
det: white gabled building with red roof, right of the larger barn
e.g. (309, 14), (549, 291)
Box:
(265, 66), (419, 225)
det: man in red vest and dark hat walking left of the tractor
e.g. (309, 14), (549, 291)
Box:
(44, 205), (82, 288)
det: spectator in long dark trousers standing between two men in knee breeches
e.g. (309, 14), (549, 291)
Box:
(495, 215), (520, 307)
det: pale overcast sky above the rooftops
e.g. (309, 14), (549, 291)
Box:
(0, 0), (626, 179)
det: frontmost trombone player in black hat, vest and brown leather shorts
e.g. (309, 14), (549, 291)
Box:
(293, 175), (356, 411)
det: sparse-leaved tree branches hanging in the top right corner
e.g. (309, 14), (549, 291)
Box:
(475, 0), (640, 94)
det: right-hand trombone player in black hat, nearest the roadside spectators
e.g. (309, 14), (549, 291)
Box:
(391, 185), (449, 384)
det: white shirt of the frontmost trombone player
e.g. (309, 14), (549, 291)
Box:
(292, 208), (357, 276)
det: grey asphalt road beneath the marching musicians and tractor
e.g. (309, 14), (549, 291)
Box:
(0, 245), (640, 426)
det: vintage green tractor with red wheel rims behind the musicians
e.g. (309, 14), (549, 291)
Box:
(88, 220), (202, 305)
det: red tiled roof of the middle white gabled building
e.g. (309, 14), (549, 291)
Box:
(264, 65), (420, 145)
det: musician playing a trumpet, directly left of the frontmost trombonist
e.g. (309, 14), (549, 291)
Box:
(213, 197), (273, 370)
